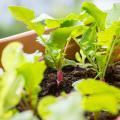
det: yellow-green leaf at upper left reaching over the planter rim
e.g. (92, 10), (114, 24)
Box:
(9, 6), (44, 35)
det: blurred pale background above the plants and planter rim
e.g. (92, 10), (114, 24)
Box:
(0, 0), (120, 38)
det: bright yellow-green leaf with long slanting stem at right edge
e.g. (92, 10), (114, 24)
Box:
(96, 22), (120, 79)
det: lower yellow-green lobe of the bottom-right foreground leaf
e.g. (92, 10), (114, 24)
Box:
(83, 94), (119, 114)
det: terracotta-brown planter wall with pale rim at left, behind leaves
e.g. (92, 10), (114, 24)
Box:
(0, 29), (52, 67)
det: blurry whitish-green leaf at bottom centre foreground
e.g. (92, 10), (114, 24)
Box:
(39, 92), (85, 120)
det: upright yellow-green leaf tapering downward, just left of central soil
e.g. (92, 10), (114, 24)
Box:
(17, 61), (46, 106)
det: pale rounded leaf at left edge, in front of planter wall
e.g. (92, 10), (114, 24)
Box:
(1, 42), (25, 71)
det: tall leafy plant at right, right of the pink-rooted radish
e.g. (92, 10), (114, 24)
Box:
(72, 2), (120, 80)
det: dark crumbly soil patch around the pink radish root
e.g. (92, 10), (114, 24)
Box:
(39, 66), (96, 97)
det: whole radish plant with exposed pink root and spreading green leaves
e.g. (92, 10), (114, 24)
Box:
(9, 2), (101, 84)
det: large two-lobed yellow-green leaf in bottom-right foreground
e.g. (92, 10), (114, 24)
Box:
(73, 79), (120, 114)
